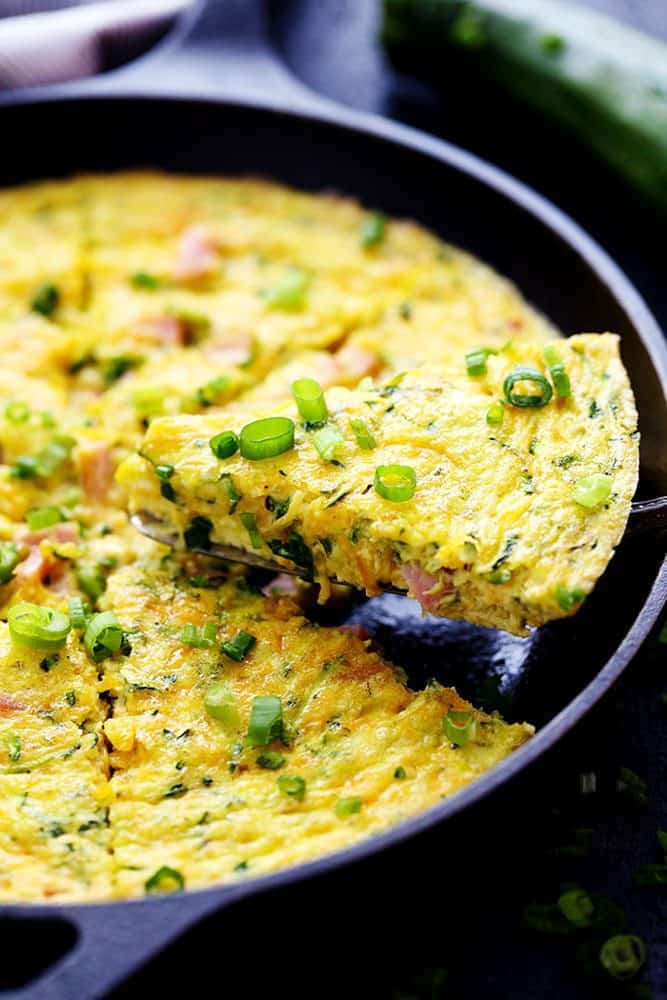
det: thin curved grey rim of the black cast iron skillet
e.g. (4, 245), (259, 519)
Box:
(0, 94), (667, 916)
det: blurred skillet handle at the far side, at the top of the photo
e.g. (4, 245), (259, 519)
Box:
(17, 0), (333, 112)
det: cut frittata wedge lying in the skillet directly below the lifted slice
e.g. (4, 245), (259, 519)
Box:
(99, 567), (532, 896)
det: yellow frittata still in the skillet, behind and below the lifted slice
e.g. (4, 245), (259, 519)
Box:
(0, 173), (604, 901)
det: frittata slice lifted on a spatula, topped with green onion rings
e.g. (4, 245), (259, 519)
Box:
(119, 334), (638, 634)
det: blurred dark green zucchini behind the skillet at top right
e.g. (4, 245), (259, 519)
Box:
(382, 0), (667, 212)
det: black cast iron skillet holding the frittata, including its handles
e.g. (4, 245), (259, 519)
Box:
(0, 0), (667, 1000)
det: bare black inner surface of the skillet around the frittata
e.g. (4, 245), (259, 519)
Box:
(0, 98), (667, 726)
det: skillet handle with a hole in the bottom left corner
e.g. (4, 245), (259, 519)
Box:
(0, 887), (240, 1000)
